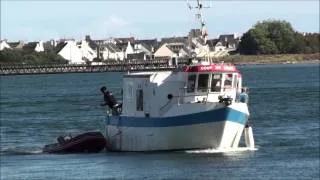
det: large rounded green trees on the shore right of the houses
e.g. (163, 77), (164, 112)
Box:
(238, 20), (320, 55)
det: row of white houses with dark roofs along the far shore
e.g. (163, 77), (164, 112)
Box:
(0, 29), (240, 64)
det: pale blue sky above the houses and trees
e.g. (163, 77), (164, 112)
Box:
(1, 0), (319, 41)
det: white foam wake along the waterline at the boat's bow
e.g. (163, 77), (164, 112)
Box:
(185, 147), (258, 154)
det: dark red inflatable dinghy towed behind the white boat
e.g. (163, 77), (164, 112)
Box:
(42, 132), (106, 153)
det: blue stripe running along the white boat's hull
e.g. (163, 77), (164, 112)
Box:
(107, 107), (248, 127)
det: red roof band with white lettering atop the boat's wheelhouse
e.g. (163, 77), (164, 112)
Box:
(184, 64), (238, 72)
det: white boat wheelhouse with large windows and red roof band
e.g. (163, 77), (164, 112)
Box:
(185, 63), (242, 105)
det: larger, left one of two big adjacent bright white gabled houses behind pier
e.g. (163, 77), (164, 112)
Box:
(57, 41), (85, 64)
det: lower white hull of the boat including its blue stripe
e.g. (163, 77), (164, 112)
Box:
(106, 106), (248, 151)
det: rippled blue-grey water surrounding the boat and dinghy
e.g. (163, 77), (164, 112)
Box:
(0, 64), (320, 180)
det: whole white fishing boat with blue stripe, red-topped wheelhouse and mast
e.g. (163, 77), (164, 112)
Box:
(105, 0), (254, 151)
